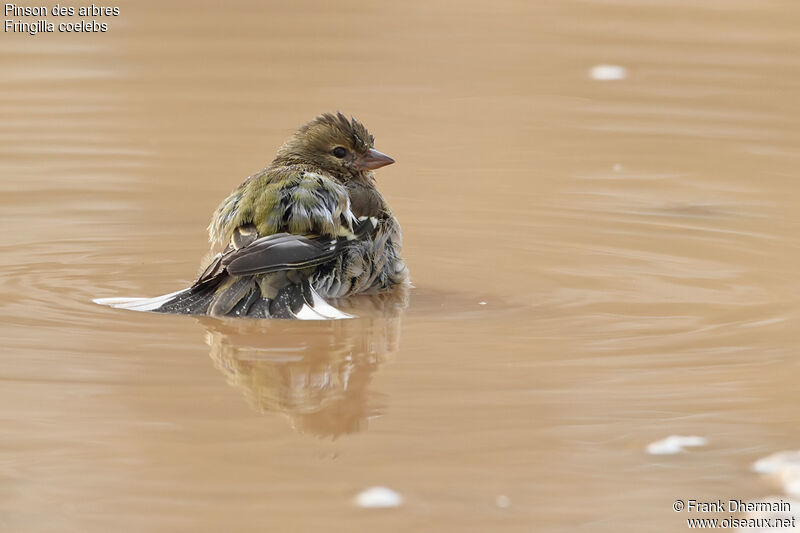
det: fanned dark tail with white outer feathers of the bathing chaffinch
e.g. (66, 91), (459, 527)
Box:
(94, 275), (354, 320)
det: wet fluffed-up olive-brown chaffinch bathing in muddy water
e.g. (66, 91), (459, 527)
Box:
(95, 112), (409, 320)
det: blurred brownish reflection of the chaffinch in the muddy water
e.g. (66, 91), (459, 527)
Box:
(194, 289), (408, 437)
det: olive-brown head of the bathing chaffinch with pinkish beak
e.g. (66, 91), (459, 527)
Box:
(274, 113), (394, 180)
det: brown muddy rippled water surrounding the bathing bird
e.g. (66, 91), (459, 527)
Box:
(0, 0), (800, 532)
